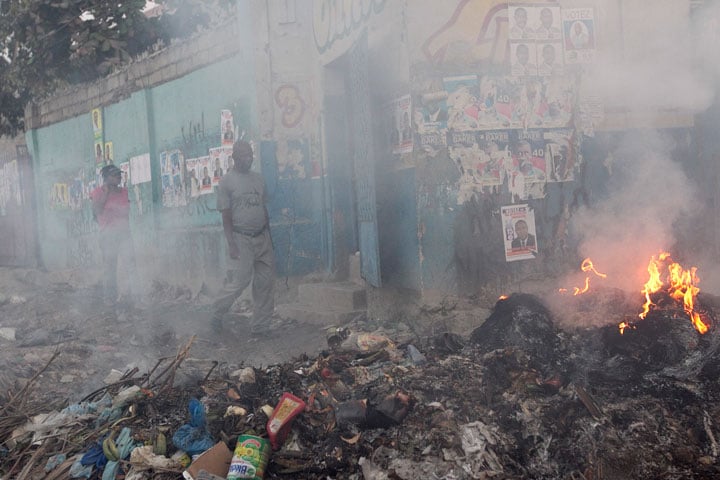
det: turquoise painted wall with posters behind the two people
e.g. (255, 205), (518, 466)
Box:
(28, 12), (260, 288)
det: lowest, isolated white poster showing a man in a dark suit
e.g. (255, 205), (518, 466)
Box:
(500, 204), (538, 262)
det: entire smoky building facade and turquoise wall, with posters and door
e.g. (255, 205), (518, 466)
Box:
(22, 0), (718, 294)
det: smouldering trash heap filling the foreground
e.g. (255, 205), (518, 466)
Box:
(0, 294), (720, 480)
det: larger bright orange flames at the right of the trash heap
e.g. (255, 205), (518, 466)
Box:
(632, 252), (709, 333)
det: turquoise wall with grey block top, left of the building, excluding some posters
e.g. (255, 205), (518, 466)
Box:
(27, 12), (260, 288)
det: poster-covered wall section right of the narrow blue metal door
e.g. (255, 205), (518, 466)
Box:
(405, 0), (708, 293)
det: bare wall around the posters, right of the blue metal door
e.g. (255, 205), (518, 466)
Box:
(404, 0), (708, 293)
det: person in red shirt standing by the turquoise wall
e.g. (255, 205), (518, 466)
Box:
(90, 164), (130, 305)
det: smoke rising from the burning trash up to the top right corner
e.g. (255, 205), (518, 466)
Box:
(572, 0), (720, 292)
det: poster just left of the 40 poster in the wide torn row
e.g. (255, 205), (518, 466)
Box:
(443, 75), (480, 132)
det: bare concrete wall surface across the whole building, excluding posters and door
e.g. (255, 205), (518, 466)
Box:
(22, 0), (714, 300)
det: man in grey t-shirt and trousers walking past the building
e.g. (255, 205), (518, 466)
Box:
(213, 140), (275, 336)
